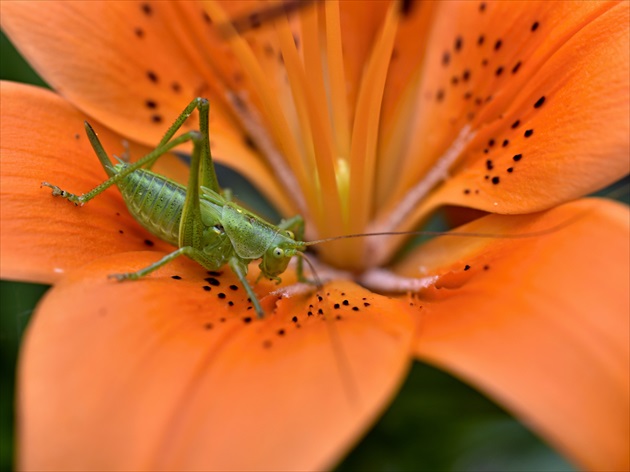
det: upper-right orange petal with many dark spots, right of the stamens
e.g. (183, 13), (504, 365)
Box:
(378, 2), (630, 229)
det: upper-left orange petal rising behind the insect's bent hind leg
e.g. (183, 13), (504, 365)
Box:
(2, 2), (291, 212)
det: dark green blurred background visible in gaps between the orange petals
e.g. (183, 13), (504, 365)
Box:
(0, 26), (608, 472)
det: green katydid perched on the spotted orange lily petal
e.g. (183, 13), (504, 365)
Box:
(42, 98), (309, 317)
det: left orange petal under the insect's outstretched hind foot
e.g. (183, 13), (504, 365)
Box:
(0, 82), (184, 283)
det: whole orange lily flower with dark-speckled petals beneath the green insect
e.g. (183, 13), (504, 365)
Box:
(0, 0), (630, 470)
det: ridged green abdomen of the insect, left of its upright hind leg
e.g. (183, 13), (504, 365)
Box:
(118, 169), (186, 246)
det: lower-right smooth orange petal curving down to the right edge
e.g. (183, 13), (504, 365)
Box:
(400, 200), (630, 470)
